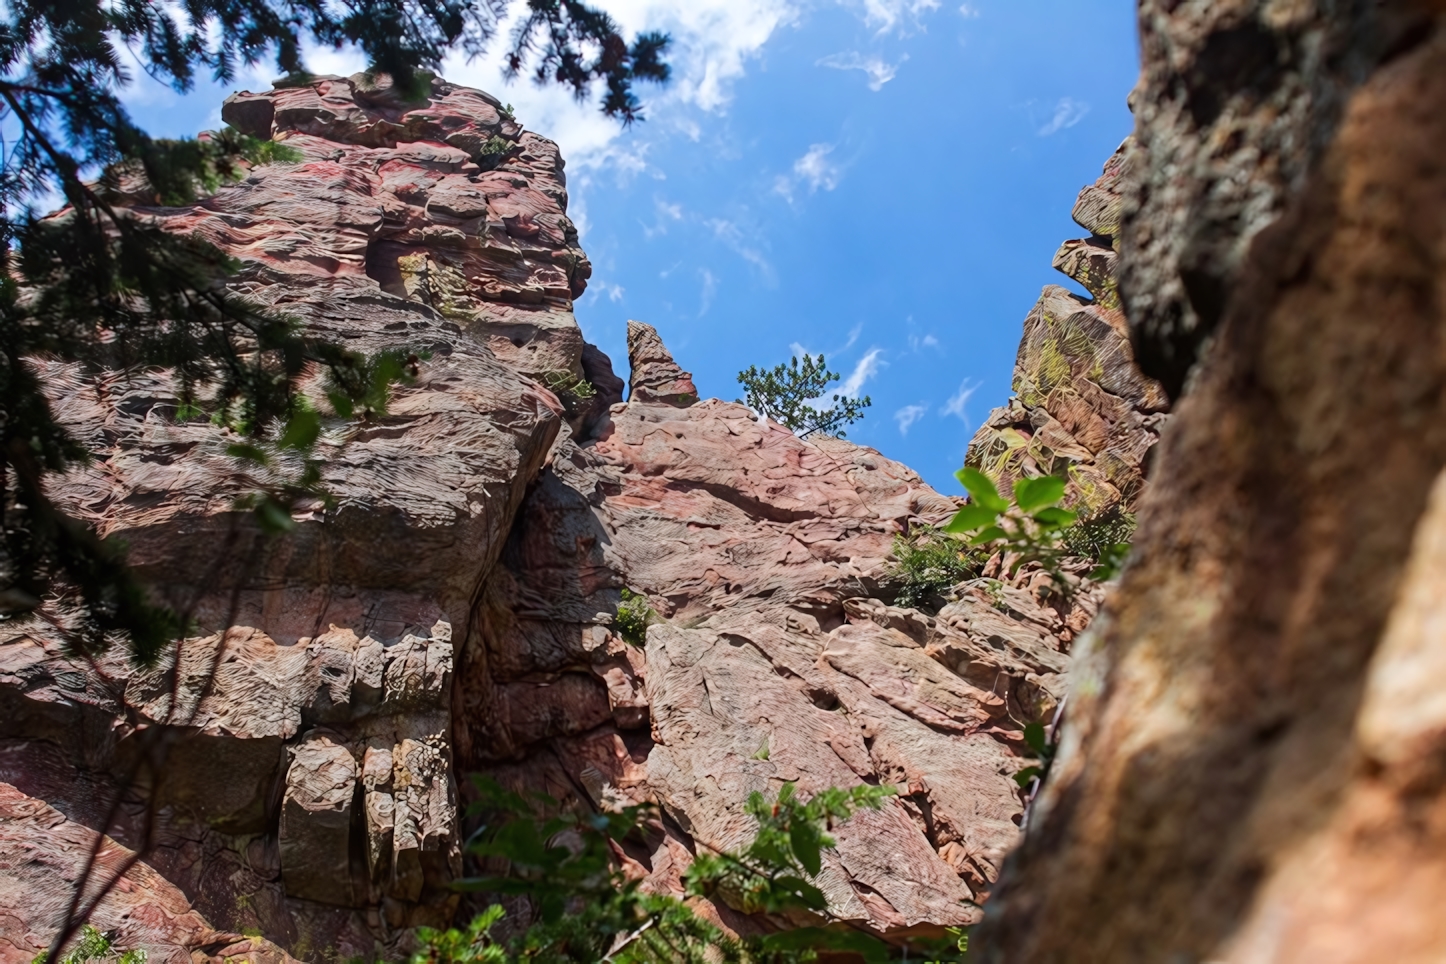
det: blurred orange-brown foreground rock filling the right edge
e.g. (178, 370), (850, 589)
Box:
(977, 1), (1446, 964)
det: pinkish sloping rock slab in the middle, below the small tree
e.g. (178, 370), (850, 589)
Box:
(468, 387), (1087, 935)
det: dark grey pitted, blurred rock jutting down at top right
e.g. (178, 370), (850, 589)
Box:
(1121, 0), (1439, 397)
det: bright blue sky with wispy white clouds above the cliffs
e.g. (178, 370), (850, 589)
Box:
(121, 0), (1138, 493)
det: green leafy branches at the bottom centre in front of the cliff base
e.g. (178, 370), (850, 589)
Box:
(412, 779), (964, 964)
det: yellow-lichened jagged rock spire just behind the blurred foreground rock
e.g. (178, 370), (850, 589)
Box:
(964, 140), (1168, 515)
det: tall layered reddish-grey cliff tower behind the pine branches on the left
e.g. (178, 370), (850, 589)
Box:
(0, 78), (575, 957)
